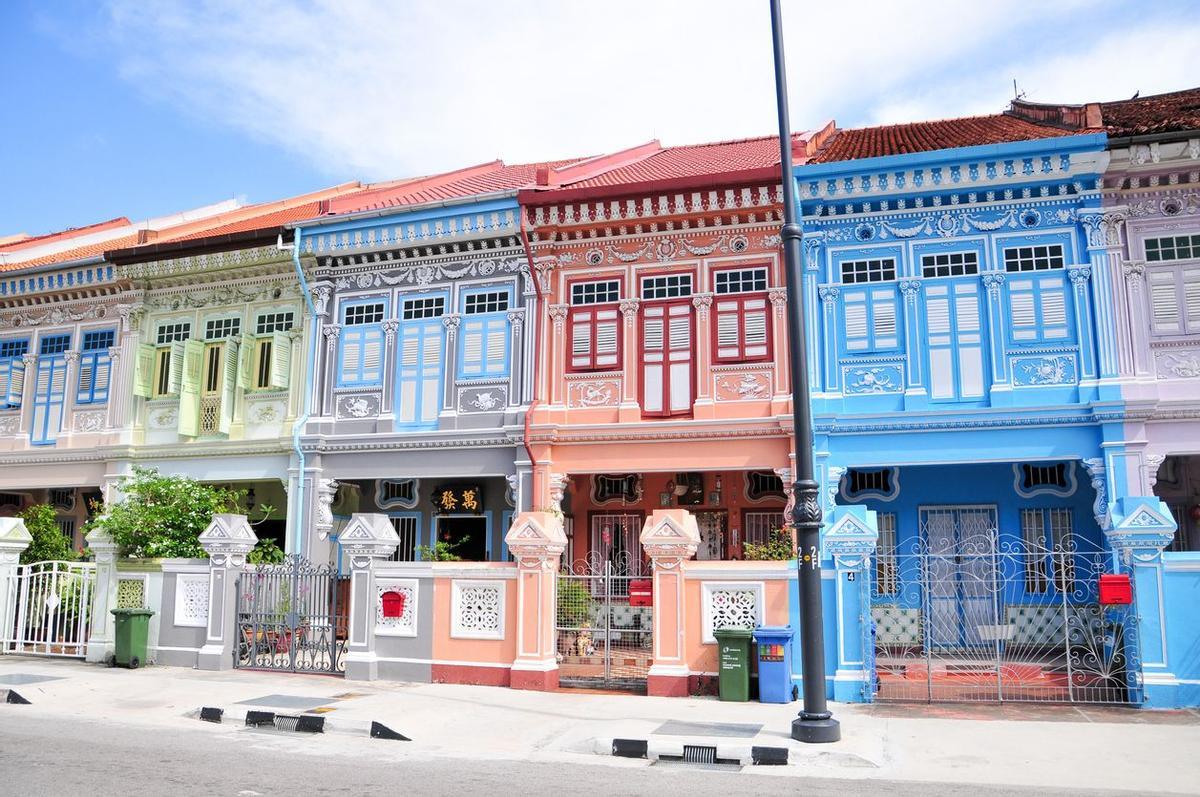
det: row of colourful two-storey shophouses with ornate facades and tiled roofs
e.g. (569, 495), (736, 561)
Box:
(0, 90), (1200, 706)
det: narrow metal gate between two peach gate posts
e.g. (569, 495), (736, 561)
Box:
(554, 553), (654, 690)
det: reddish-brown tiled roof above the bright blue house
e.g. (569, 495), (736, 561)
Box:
(811, 114), (1075, 163)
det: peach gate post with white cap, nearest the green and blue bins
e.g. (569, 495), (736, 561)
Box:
(641, 509), (700, 697)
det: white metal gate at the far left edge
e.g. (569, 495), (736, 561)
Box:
(0, 562), (96, 658)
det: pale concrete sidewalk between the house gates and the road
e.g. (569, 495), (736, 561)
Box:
(0, 657), (1200, 793)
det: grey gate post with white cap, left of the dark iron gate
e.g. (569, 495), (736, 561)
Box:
(196, 515), (258, 670)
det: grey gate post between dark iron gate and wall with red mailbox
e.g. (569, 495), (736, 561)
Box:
(335, 513), (400, 681)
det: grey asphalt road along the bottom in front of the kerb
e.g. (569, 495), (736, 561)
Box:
(0, 706), (1161, 797)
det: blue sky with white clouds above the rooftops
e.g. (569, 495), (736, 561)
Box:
(0, 0), (1200, 235)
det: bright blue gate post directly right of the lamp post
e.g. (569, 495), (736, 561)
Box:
(822, 507), (880, 703)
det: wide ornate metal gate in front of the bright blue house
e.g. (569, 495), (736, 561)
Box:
(871, 516), (1142, 703)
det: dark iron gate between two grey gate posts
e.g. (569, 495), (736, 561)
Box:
(234, 555), (350, 673)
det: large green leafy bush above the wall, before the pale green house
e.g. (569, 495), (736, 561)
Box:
(86, 467), (253, 558)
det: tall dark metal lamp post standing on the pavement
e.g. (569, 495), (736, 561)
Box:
(770, 0), (841, 743)
